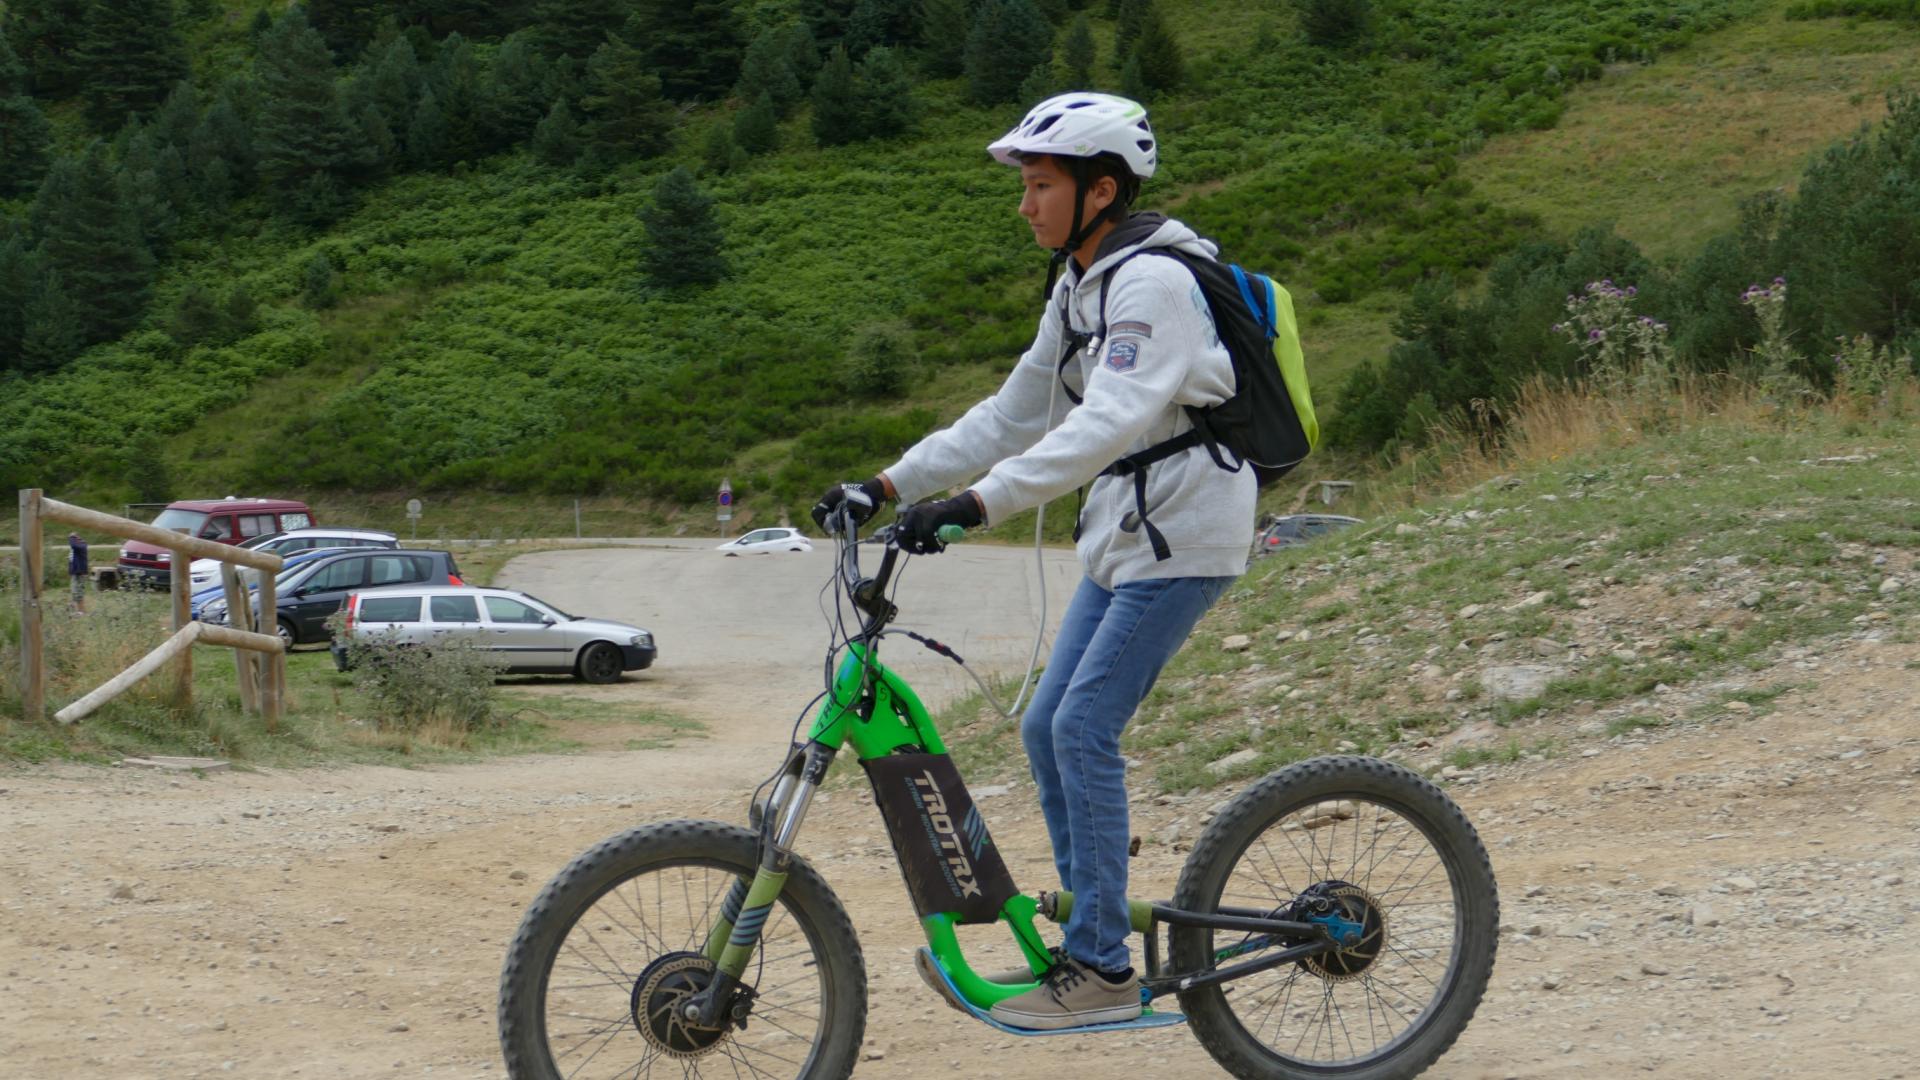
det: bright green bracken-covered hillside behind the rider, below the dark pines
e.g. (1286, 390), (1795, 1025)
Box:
(0, 0), (1851, 522)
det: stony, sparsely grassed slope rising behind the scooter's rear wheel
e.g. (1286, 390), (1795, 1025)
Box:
(947, 379), (1920, 792)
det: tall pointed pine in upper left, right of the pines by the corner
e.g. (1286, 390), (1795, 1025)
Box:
(255, 8), (353, 215)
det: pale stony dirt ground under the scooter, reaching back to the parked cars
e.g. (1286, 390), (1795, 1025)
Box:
(0, 550), (1920, 1080)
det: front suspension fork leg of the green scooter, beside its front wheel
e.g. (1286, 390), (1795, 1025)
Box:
(682, 742), (835, 1028)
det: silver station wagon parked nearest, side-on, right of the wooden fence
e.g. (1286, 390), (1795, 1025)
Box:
(334, 584), (657, 682)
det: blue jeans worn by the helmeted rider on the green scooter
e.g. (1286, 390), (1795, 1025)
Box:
(1020, 577), (1235, 970)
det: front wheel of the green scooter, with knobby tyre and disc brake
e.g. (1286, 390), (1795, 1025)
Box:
(499, 821), (866, 1080)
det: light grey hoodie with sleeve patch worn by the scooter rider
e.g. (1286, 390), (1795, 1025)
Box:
(887, 213), (1260, 588)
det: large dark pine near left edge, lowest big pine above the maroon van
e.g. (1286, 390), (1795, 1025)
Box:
(31, 140), (154, 344)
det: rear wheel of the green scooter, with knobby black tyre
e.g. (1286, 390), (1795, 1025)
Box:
(1169, 757), (1500, 1080)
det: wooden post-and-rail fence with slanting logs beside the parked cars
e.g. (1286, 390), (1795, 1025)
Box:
(19, 488), (286, 730)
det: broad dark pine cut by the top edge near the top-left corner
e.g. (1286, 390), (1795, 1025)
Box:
(79, 0), (186, 131)
